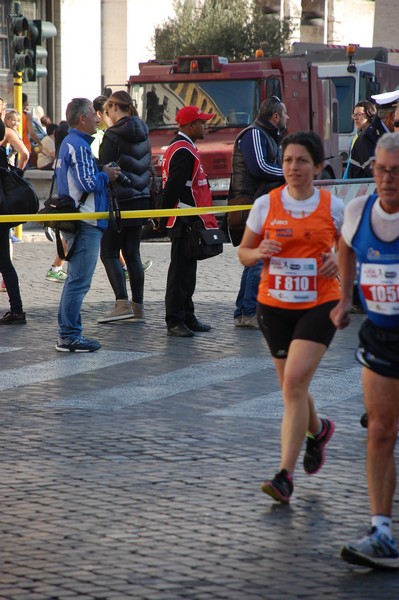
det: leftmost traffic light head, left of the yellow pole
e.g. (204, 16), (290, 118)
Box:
(7, 15), (34, 81)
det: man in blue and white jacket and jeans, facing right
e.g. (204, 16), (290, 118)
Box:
(55, 98), (121, 352)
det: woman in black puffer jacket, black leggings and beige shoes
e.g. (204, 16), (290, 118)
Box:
(98, 91), (151, 323)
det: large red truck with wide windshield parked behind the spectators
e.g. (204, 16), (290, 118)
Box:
(128, 56), (342, 209)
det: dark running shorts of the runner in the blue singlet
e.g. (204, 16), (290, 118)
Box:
(355, 319), (399, 379)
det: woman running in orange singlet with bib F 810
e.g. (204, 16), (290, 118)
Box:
(238, 132), (344, 503)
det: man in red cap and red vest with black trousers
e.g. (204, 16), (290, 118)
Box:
(160, 106), (217, 338)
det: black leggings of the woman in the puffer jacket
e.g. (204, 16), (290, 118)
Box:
(100, 223), (144, 304)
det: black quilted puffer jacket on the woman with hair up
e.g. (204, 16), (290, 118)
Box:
(99, 116), (151, 217)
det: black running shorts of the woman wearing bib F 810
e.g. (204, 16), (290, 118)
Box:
(258, 300), (338, 358)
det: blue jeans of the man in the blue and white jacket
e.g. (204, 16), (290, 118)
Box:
(58, 221), (103, 342)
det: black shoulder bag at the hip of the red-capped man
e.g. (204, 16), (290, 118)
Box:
(184, 220), (227, 260)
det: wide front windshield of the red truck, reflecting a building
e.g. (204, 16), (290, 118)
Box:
(130, 80), (260, 129)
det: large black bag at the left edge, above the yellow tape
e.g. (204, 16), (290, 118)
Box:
(0, 167), (39, 229)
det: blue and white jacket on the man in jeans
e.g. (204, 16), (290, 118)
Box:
(55, 128), (109, 229)
